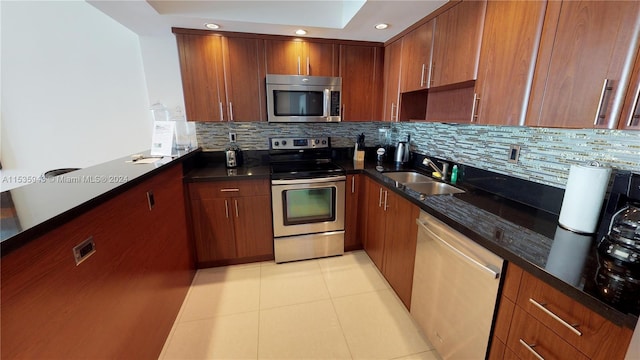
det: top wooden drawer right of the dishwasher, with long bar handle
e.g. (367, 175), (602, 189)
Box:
(511, 272), (632, 359)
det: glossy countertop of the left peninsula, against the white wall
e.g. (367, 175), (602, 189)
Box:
(0, 149), (200, 256)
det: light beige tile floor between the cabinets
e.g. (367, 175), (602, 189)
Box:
(160, 251), (439, 359)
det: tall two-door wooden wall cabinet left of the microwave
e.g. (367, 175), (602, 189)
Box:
(174, 30), (266, 121)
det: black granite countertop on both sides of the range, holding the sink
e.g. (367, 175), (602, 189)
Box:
(185, 152), (638, 329)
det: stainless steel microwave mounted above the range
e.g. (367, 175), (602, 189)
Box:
(266, 74), (342, 122)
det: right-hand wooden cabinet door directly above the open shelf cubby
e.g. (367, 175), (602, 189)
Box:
(431, 1), (487, 87)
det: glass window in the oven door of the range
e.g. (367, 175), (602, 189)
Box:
(282, 187), (336, 225)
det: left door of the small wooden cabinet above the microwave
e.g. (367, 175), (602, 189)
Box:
(265, 40), (304, 75)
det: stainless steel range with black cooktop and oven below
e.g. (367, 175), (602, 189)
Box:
(269, 137), (346, 263)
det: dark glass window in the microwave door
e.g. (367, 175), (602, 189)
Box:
(273, 90), (324, 116)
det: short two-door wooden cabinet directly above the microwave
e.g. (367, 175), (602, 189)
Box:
(265, 39), (339, 76)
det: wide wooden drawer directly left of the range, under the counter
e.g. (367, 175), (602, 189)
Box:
(189, 179), (271, 199)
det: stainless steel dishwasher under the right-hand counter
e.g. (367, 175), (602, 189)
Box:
(411, 211), (504, 359)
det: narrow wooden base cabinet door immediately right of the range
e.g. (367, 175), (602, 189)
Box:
(344, 174), (364, 251)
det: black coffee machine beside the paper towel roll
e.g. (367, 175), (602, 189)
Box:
(596, 171), (640, 314)
